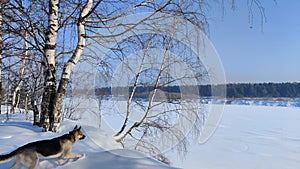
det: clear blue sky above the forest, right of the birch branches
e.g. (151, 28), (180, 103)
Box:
(209, 0), (300, 82)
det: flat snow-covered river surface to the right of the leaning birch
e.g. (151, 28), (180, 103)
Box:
(173, 105), (300, 169)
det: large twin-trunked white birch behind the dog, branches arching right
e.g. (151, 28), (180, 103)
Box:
(5, 0), (263, 134)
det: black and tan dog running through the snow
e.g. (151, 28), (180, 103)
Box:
(0, 125), (85, 169)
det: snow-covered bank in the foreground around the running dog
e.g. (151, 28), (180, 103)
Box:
(0, 114), (176, 169)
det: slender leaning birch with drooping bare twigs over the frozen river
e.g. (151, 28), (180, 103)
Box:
(99, 31), (206, 163)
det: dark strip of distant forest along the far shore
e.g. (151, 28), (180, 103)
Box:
(96, 83), (300, 98)
